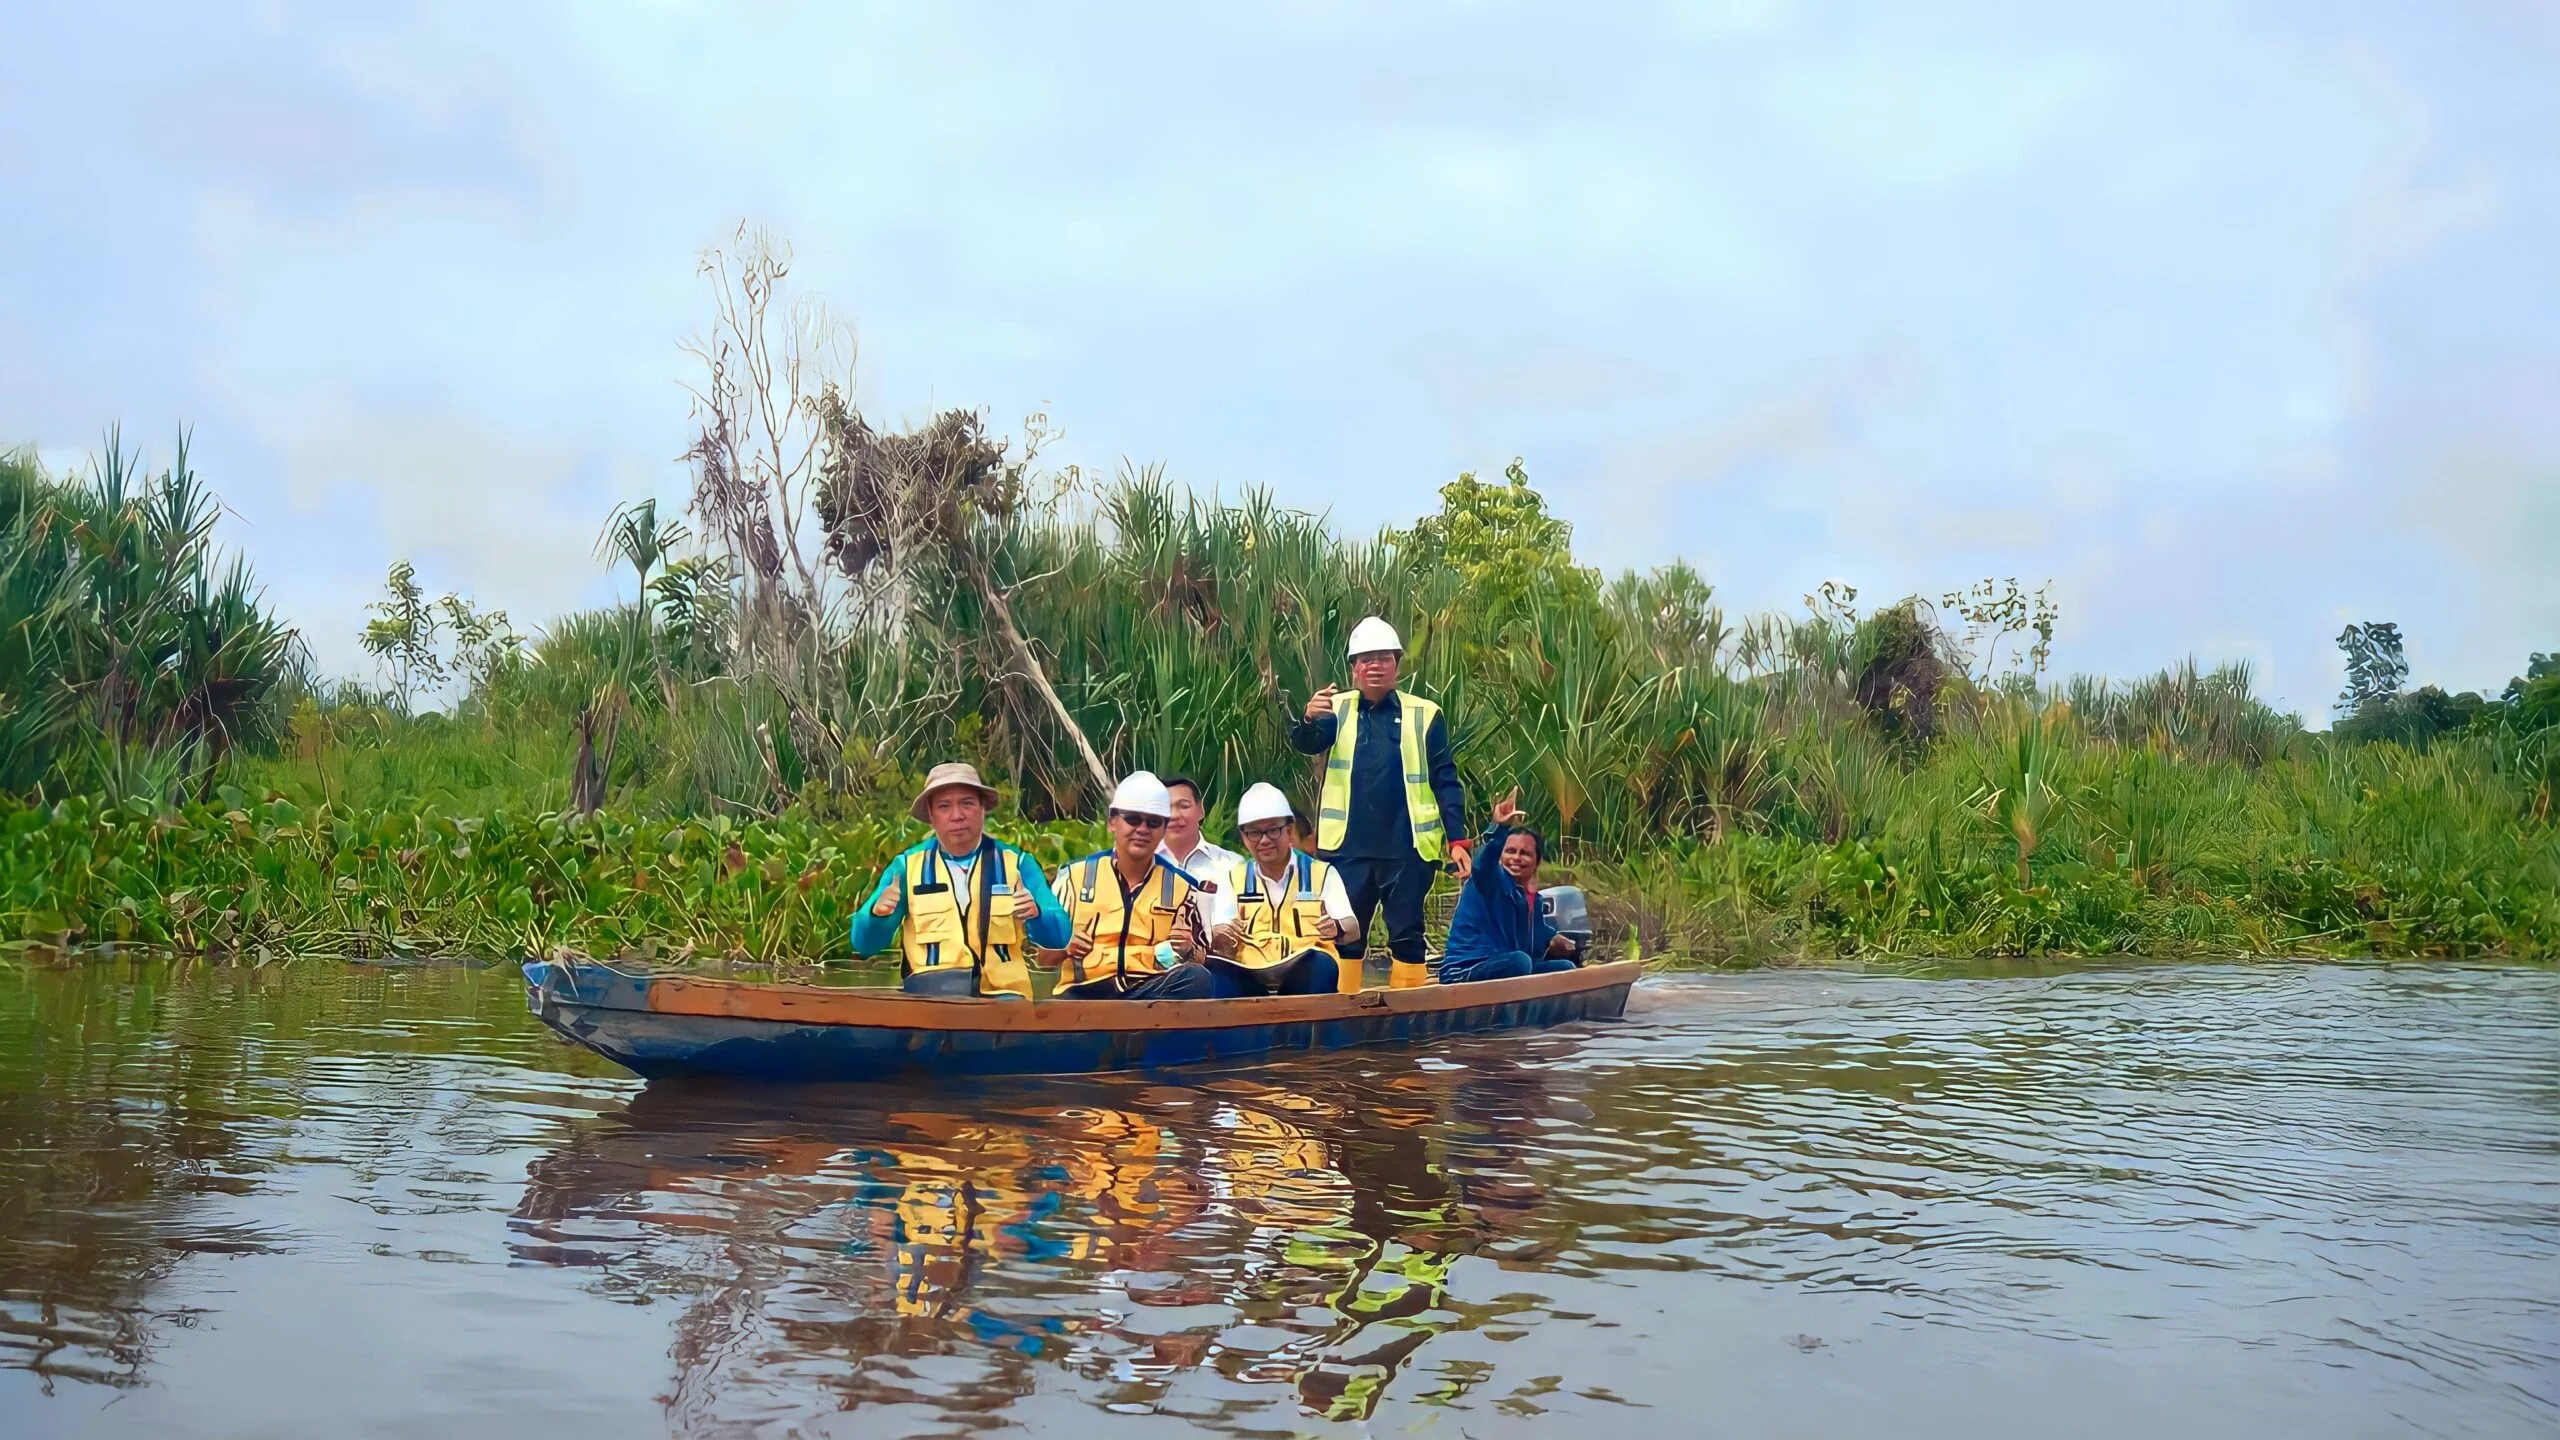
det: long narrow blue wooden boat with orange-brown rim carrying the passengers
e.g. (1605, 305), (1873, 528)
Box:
(525, 961), (1644, 1081)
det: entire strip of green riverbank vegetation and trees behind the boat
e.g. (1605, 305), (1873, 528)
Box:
(0, 235), (2560, 963)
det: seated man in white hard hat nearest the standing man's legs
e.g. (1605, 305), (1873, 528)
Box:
(1203, 784), (1359, 994)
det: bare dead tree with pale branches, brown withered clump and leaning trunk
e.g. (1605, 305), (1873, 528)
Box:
(686, 225), (1111, 789)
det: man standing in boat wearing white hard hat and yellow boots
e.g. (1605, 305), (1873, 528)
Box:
(1290, 615), (1472, 986)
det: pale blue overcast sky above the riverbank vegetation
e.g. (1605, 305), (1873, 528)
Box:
(0, 0), (2560, 723)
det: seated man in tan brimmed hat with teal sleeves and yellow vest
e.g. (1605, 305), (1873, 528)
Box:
(852, 764), (1068, 999)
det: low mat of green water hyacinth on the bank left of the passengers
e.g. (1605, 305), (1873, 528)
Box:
(0, 792), (1101, 961)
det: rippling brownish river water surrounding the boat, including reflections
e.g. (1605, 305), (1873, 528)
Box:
(0, 961), (2560, 1440)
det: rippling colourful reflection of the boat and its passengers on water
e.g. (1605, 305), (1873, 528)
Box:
(512, 1038), (1574, 1427)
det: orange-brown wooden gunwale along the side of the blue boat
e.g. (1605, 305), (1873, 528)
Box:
(527, 961), (1644, 1035)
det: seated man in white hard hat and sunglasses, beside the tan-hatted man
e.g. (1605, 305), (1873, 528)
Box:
(1042, 771), (1219, 999)
